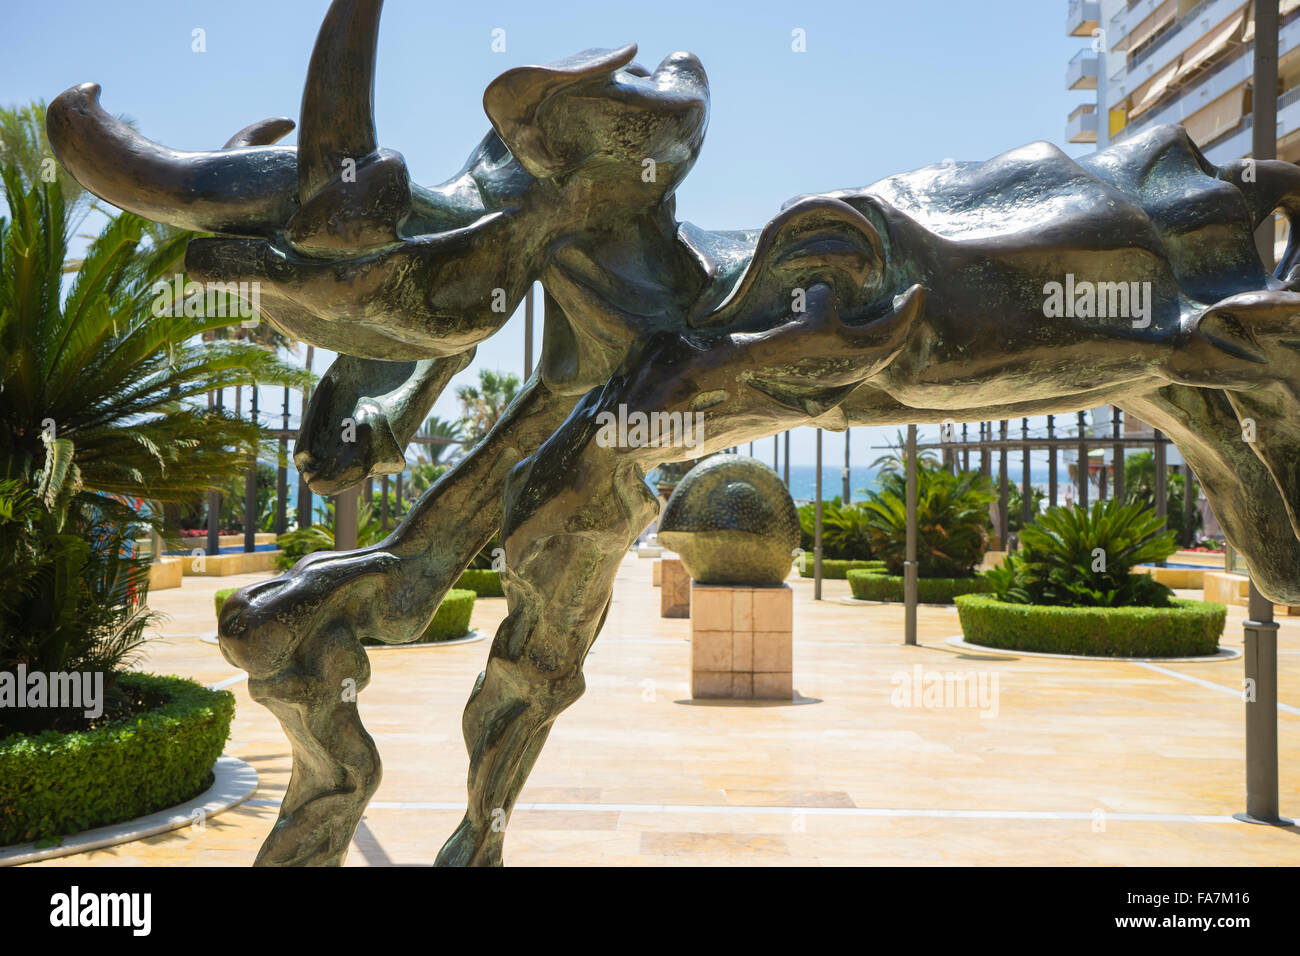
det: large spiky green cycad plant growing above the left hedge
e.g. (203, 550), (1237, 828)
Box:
(0, 164), (308, 723)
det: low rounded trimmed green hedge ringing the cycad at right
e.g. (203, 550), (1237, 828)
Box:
(957, 594), (1227, 657)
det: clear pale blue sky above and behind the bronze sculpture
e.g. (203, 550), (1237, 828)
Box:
(0, 0), (1088, 463)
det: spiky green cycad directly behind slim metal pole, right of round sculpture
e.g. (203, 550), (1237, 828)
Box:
(863, 464), (997, 578)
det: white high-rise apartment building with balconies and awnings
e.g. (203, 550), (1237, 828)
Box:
(1066, 0), (1300, 164)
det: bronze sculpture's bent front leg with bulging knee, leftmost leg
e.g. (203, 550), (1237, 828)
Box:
(218, 382), (569, 866)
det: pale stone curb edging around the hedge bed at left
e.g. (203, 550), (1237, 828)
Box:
(0, 756), (257, 866)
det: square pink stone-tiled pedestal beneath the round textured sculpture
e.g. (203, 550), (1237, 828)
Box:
(691, 580), (794, 700)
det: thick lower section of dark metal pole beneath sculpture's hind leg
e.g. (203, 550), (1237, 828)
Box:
(1232, 580), (1291, 826)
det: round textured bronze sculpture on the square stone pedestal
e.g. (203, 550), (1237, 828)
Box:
(659, 455), (800, 587)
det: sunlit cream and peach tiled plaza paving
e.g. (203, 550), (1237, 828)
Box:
(22, 555), (1300, 866)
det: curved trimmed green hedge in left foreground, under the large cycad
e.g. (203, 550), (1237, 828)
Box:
(0, 674), (235, 845)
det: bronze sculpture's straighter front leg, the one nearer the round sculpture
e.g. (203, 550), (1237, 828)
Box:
(438, 393), (657, 866)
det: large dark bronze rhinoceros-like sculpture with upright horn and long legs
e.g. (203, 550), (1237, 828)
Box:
(48, 0), (1300, 865)
